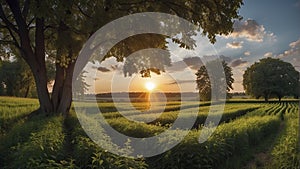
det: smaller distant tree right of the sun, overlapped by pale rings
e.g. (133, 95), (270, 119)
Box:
(196, 60), (234, 100)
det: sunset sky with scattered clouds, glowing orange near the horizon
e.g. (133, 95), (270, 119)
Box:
(85, 0), (300, 93)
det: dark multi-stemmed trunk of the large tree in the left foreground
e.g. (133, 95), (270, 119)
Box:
(6, 0), (75, 115)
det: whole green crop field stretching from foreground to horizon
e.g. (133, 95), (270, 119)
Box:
(0, 97), (300, 169)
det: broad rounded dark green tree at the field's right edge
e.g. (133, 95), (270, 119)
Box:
(243, 58), (299, 102)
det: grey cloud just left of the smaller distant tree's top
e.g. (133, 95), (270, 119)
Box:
(167, 56), (203, 72)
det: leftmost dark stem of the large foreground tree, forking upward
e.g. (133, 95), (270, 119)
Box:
(6, 0), (53, 114)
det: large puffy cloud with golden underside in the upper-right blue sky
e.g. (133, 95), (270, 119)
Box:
(229, 19), (275, 42)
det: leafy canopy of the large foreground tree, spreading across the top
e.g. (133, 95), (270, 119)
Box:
(0, 0), (243, 74)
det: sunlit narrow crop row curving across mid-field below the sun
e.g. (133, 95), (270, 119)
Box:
(100, 104), (259, 129)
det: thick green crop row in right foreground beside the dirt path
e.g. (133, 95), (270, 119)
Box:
(150, 116), (280, 169)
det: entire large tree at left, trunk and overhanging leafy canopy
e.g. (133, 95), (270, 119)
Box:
(0, 0), (242, 113)
